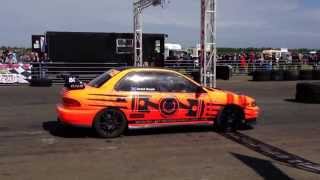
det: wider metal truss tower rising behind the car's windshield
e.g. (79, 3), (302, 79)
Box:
(200, 0), (217, 88)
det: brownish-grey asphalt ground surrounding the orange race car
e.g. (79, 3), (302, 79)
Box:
(0, 77), (320, 180)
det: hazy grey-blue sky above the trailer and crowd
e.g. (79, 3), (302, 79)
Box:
(0, 0), (320, 48)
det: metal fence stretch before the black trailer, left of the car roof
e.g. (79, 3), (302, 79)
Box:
(31, 62), (127, 83)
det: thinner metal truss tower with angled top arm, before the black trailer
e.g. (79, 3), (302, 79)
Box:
(133, 0), (165, 67)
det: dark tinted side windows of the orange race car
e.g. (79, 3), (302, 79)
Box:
(116, 72), (198, 93)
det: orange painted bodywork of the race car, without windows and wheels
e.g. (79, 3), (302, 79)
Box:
(56, 68), (259, 128)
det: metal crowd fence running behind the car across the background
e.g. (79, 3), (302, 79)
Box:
(31, 60), (320, 83)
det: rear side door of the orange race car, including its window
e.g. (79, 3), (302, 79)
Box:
(115, 71), (161, 124)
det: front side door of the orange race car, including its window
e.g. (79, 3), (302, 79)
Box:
(158, 72), (209, 121)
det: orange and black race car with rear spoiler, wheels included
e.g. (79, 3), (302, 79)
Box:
(57, 68), (259, 138)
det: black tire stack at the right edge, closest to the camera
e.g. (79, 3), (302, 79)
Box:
(296, 83), (320, 103)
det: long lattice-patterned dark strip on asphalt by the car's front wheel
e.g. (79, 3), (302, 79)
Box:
(220, 132), (320, 174)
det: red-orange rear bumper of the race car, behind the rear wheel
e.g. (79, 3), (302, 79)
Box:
(56, 104), (97, 127)
